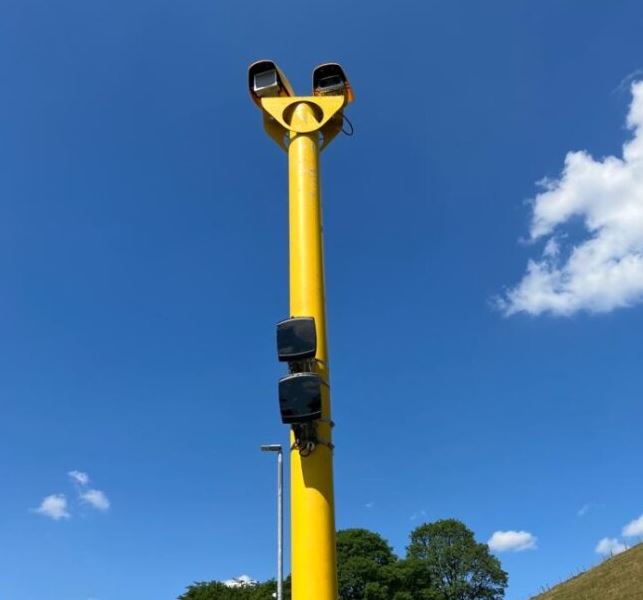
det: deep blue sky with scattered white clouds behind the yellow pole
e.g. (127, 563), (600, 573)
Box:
(0, 0), (643, 600)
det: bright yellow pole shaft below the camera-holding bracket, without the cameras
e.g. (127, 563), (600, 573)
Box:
(288, 102), (337, 600)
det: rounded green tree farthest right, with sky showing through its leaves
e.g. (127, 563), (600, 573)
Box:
(406, 519), (507, 600)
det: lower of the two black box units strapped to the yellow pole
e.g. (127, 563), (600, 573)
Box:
(279, 373), (323, 424)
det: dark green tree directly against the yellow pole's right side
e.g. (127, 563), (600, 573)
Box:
(337, 529), (397, 600)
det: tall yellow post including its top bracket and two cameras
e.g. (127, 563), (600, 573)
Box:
(248, 60), (353, 600)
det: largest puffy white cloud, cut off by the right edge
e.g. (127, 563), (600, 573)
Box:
(498, 82), (643, 316)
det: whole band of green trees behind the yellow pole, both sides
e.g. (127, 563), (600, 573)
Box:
(179, 519), (507, 600)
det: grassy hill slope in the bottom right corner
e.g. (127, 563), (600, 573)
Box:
(532, 544), (643, 600)
